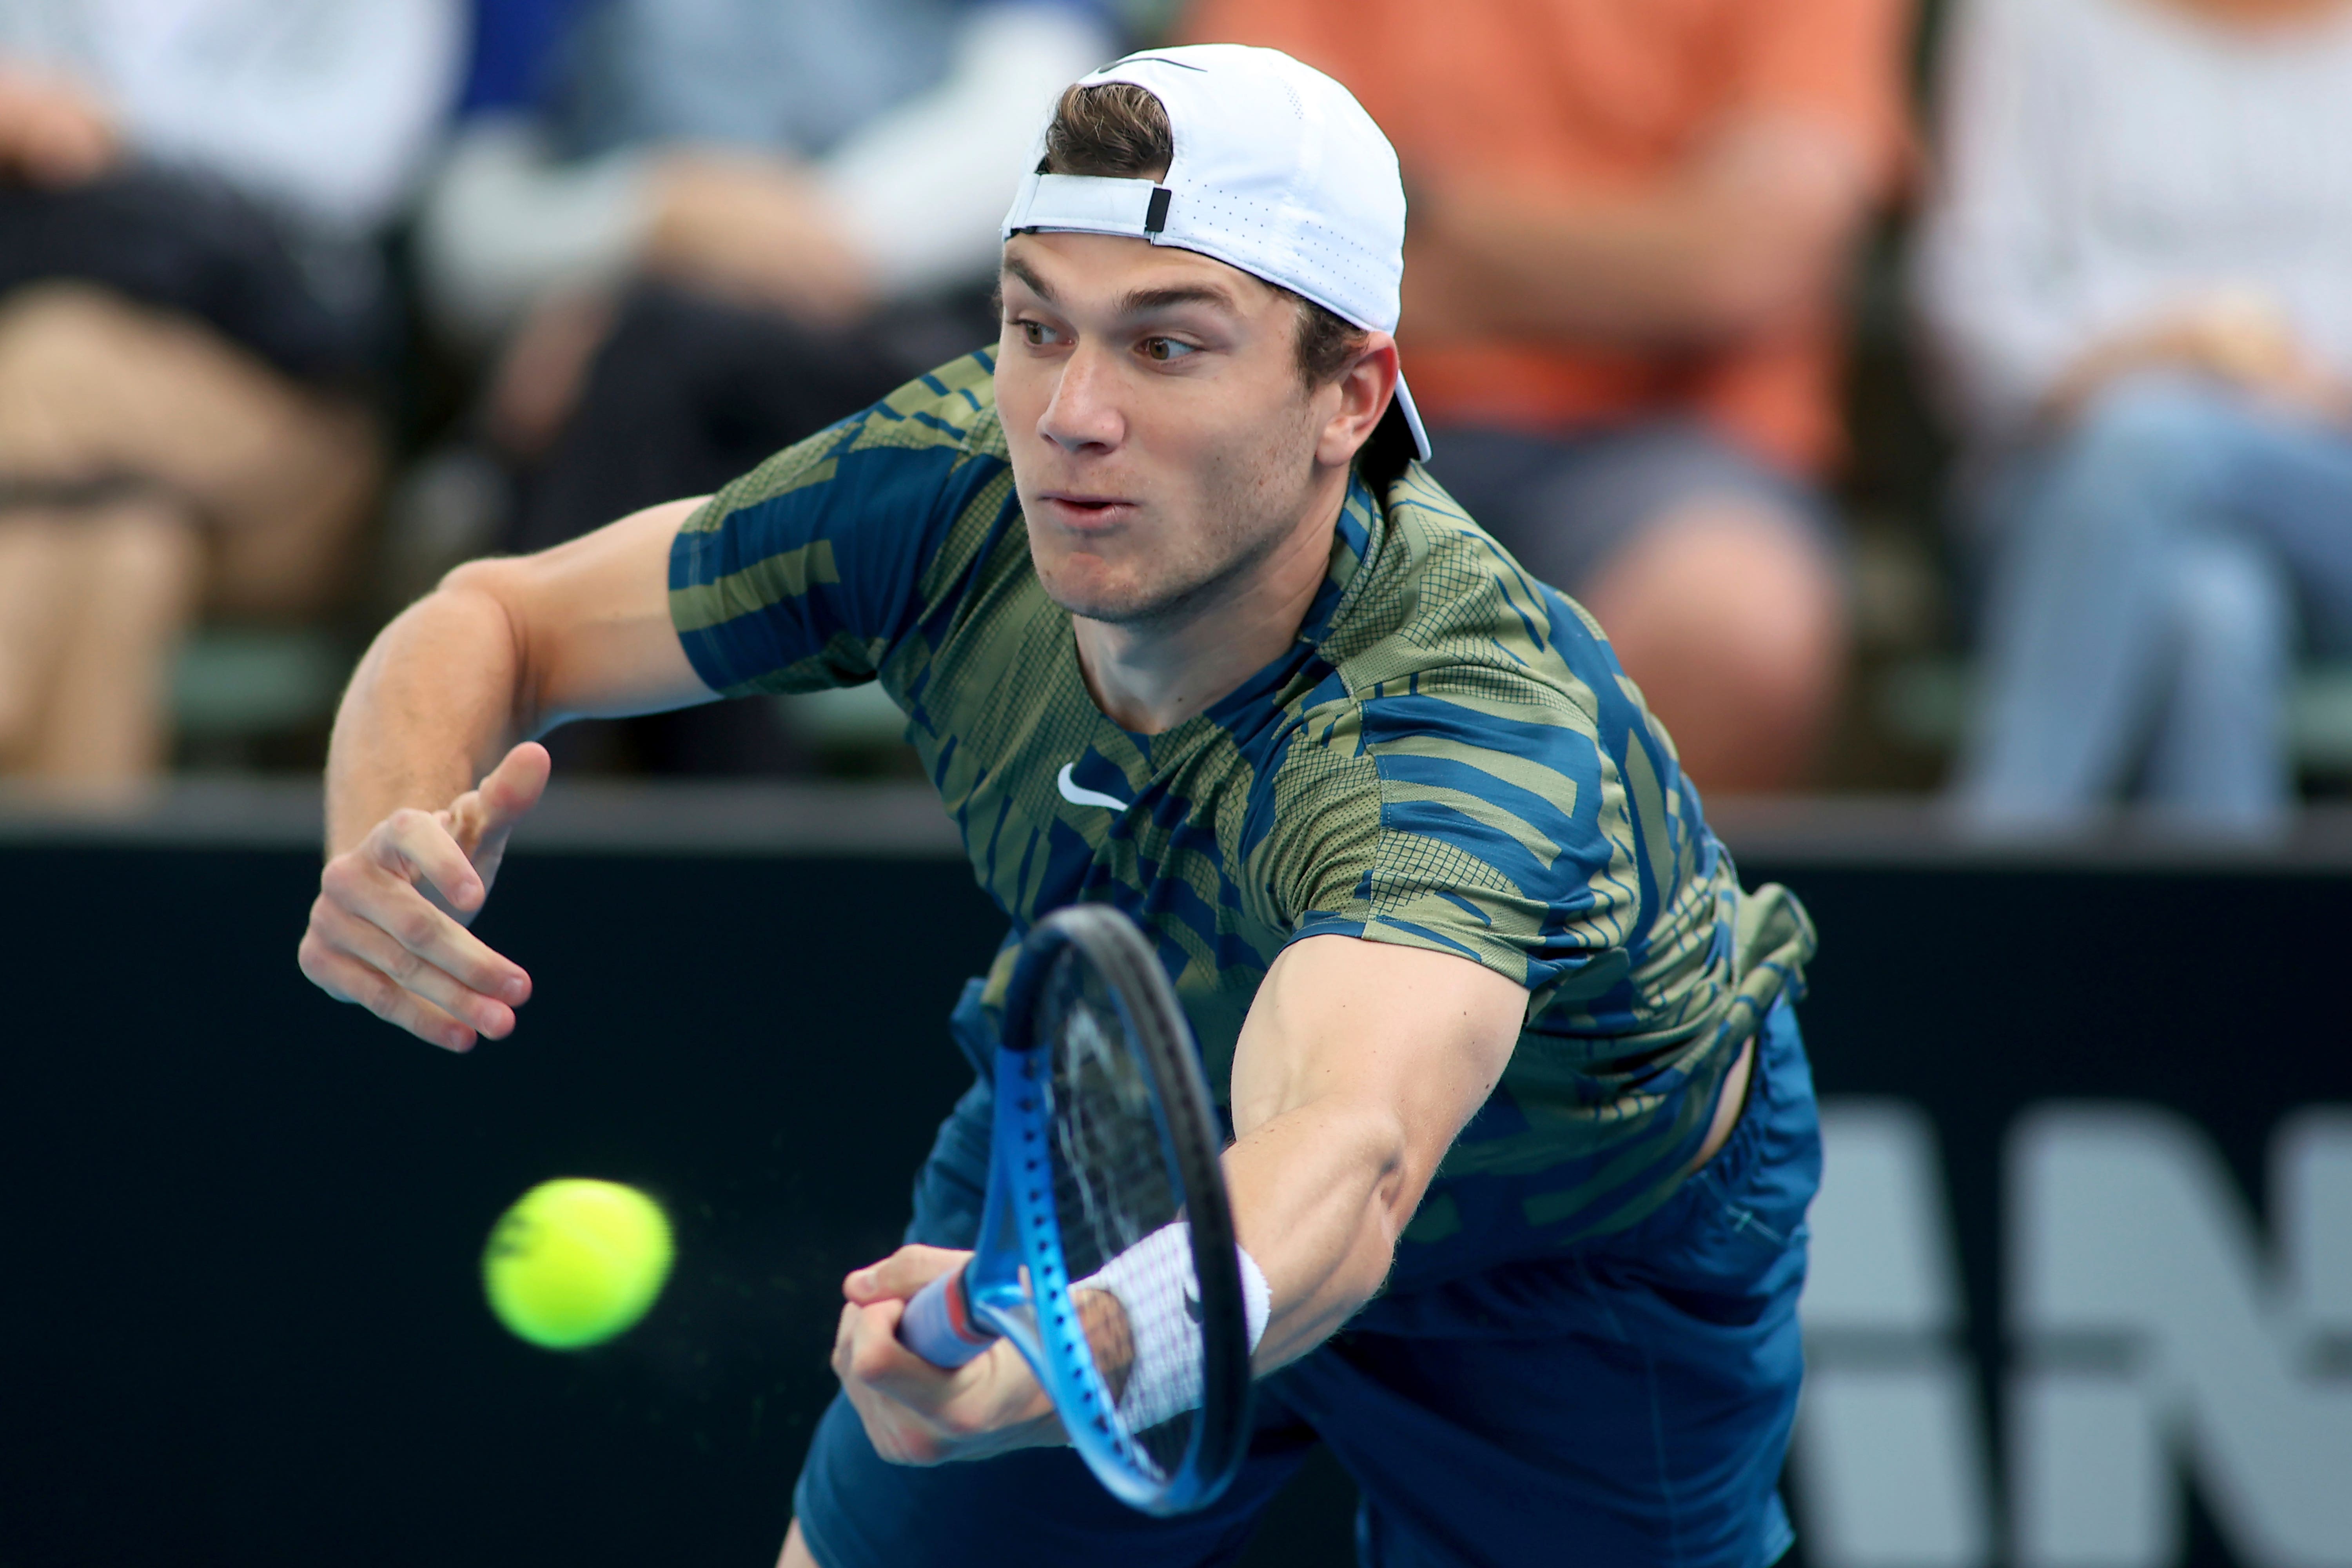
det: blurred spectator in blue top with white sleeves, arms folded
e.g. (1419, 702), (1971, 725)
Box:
(423, 0), (1117, 771)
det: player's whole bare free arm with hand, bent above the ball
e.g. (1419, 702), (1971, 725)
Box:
(301, 501), (715, 1051)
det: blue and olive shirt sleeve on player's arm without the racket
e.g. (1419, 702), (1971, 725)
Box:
(670, 355), (1016, 696)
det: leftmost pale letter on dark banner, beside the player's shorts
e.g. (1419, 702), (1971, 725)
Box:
(1795, 1100), (1992, 1568)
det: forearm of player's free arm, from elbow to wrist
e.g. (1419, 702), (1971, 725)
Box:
(327, 588), (534, 856)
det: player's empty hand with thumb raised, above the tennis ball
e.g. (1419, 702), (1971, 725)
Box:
(301, 740), (550, 1051)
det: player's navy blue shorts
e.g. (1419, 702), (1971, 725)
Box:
(793, 1006), (1820, 1568)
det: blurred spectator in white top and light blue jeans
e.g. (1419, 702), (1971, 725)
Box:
(1919, 0), (2352, 830)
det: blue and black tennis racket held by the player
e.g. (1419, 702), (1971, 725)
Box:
(898, 905), (1249, 1514)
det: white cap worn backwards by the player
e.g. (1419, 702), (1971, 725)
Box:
(1004, 45), (1430, 458)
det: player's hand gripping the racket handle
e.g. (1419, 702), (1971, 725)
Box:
(833, 1246), (1065, 1465)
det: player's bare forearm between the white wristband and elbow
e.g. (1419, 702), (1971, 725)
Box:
(1225, 1100), (1430, 1373)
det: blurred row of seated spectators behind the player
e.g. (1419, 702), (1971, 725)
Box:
(0, 0), (2352, 832)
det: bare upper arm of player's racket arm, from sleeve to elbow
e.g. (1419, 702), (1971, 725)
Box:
(1232, 936), (1526, 1201)
